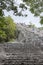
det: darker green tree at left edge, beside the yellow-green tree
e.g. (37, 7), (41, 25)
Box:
(0, 17), (6, 42)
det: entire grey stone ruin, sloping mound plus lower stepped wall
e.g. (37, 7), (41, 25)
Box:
(0, 25), (43, 65)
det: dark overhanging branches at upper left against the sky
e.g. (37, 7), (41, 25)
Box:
(0, 0), (27, 16)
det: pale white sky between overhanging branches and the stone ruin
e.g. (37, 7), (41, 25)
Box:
(4, 0), (41, 27)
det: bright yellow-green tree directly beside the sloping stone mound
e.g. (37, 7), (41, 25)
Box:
(5, 16), (16, 39)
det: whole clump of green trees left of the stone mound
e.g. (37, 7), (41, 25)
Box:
(0, 16), (16, 42)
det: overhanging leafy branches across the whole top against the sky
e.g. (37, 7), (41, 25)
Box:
(0, 0), (43, 23)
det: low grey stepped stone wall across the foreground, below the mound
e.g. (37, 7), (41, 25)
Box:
(0, 43), (43, 65)
